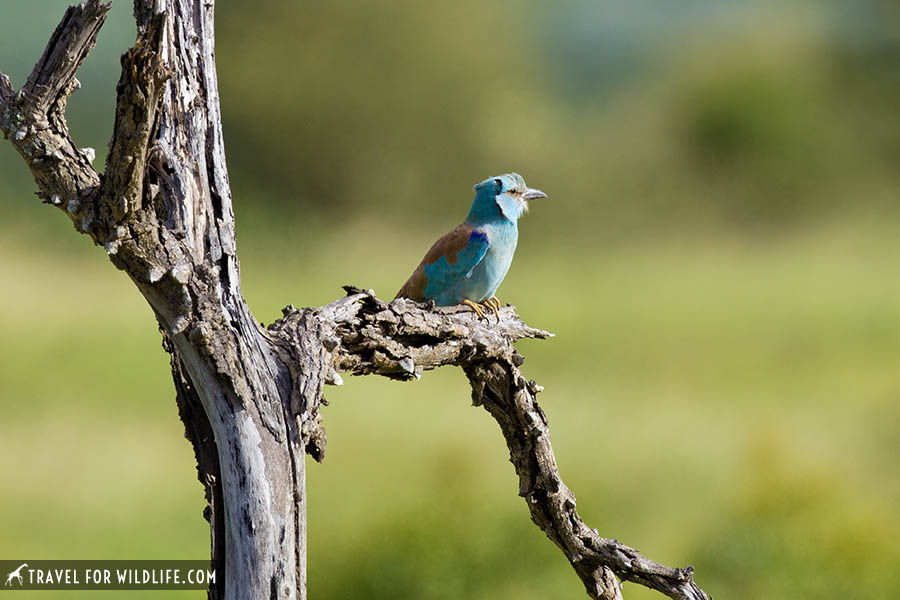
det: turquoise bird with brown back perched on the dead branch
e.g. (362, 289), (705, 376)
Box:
(397, 173), (547, 317)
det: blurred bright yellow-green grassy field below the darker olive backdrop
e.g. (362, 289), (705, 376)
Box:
(0, 215), (900, 600)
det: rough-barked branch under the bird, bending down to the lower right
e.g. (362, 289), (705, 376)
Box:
(268, 286), (708, 600)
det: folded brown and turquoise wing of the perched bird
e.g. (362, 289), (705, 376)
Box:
(397, 223), (488, 301)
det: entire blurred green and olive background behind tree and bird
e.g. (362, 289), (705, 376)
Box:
(0, 0), (900, 599)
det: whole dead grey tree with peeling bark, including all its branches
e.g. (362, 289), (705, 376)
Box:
(0, 0), (707, 600)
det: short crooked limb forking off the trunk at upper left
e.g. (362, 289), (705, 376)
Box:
(0, 0), (111, 232)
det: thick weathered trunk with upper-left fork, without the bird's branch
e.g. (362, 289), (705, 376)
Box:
(3, 0), (306, 598)
